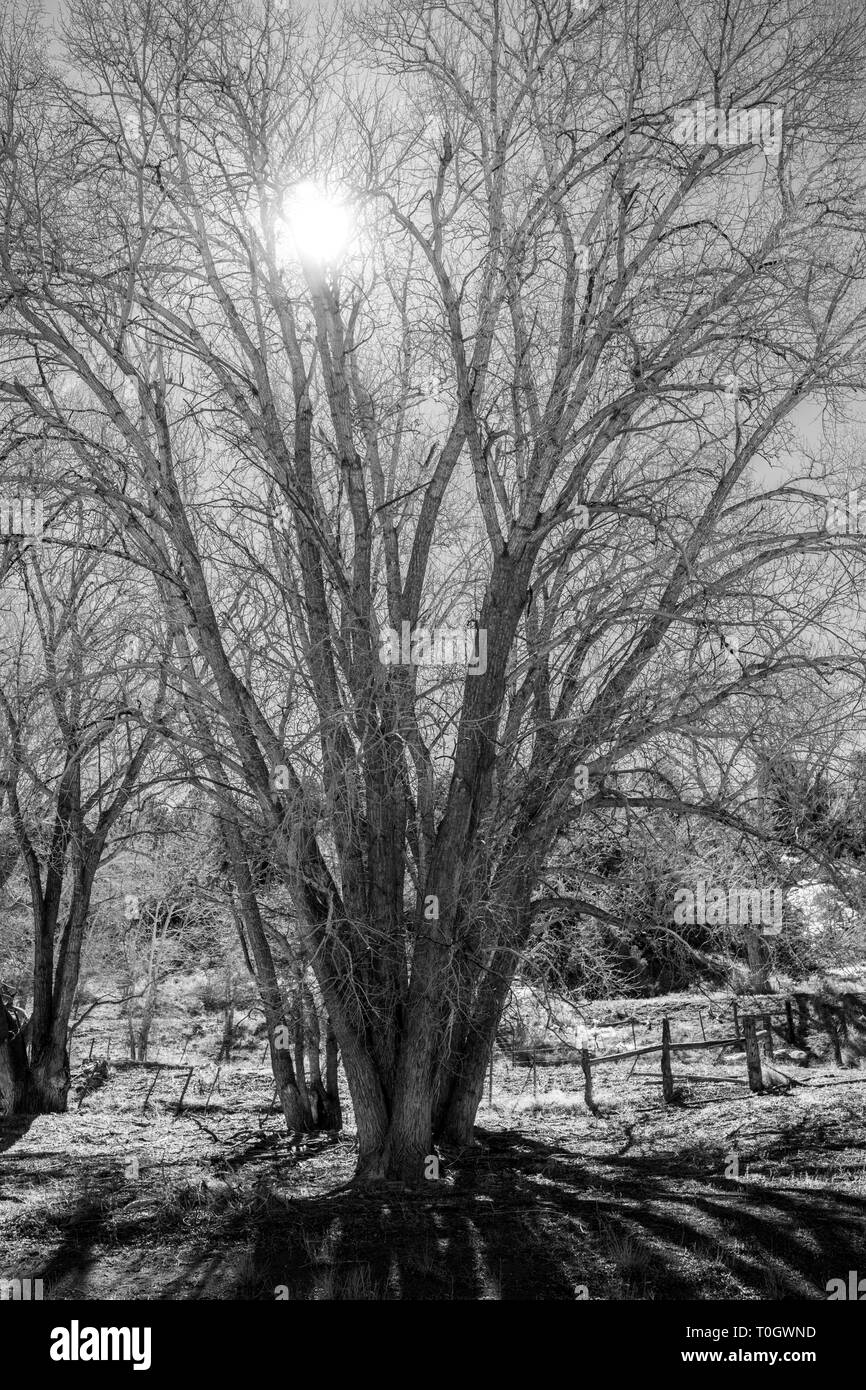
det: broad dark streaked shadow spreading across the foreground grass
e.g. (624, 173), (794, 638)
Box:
(13, 1131), (866, 1301)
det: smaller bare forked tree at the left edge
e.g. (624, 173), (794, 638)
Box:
(0, 532), (167, 1113)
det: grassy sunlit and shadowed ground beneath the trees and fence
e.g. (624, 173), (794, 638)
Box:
(0, 978), (866, 1300)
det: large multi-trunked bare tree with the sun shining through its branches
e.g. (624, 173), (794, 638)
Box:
(0, 0), (865, 1180)
